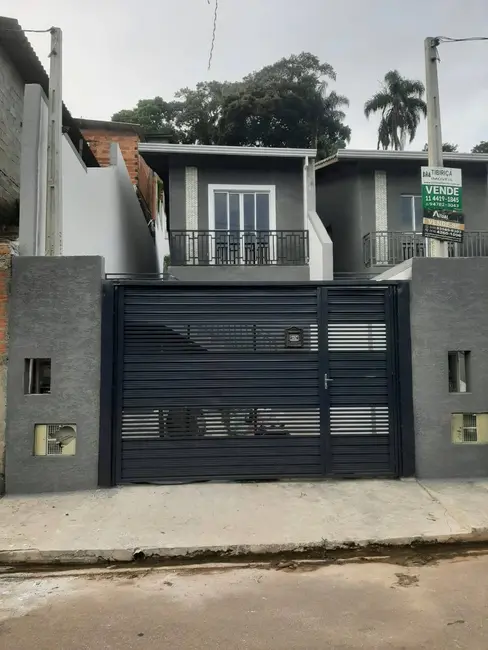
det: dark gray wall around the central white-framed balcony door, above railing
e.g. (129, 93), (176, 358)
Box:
(169, 156), (304, 230)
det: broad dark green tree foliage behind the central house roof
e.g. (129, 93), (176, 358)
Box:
(112, 52), (351, 157)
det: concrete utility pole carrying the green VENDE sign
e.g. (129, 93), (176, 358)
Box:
(425, 36), (448, 257)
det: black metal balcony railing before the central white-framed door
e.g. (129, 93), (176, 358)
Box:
(169, 230), (309, 266)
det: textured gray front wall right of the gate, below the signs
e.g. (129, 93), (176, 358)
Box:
(411, 258), (488, 478)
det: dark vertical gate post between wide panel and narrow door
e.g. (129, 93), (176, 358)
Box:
(317, 287), (332, 476)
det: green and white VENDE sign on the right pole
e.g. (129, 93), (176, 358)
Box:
(421, 167), (463, 212)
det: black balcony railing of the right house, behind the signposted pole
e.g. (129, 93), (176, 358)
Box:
(363, 230), (488, 268)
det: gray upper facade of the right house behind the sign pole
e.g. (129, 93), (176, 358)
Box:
(315, 149), (488, 275)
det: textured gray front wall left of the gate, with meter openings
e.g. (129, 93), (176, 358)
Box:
(6, 257), (103, 494)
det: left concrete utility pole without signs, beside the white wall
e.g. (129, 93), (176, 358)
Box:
(45, 27), (63, 256)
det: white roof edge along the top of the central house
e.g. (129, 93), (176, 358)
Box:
(139, 142), (317, 158)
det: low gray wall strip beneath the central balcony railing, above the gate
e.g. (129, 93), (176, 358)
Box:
(170, 265), (310, 282)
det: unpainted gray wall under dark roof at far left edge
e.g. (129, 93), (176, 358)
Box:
(0, 47), (24, 226)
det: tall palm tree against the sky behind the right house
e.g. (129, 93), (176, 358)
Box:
(364, 70), (427, 151)
